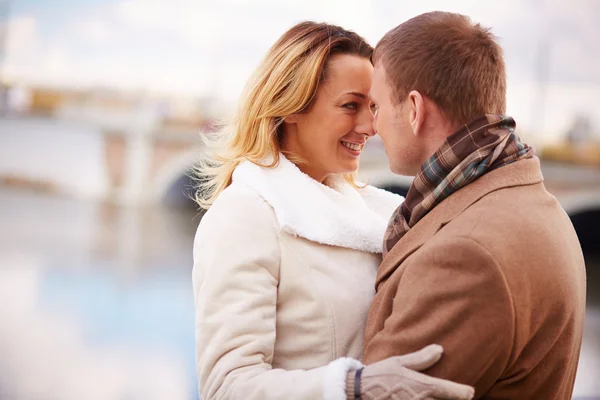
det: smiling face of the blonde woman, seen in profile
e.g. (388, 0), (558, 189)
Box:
(282, 55), (375, 182)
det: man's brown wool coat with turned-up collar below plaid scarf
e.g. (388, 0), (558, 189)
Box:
(363, 157), (585, 400)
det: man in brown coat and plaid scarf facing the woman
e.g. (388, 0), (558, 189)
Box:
(347, 12), (585, 400)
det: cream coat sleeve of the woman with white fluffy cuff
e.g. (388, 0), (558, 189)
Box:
(193, 191), (362, 400)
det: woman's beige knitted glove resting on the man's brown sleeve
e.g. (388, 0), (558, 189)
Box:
(346, 344), (475, 400)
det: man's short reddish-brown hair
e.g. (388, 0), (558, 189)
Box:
(373, 11), (506, 124)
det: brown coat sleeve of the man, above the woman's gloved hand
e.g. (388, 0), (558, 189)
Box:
(363, 237), (515, 398)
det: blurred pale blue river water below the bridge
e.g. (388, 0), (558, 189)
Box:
(0, 189), (600, 400)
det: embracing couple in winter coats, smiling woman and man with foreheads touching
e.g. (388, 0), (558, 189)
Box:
(193, 12), (585, 400)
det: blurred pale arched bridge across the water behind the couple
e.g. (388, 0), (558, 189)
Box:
(0, 116), (600, 249)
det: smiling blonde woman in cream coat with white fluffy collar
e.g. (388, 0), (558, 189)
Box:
(193, 22), (468, 399)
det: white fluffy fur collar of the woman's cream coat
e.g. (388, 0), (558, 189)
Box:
(233, 154), (403, 253)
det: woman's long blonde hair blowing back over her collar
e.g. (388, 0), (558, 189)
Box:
(193, 22), (373, 209)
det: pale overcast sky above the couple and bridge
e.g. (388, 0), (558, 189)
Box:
(2, 0), (600, 138)
